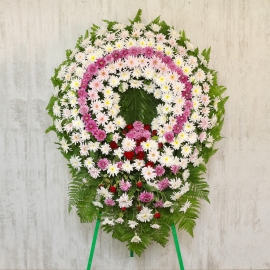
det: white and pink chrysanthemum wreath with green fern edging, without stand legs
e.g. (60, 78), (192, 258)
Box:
(47, 10), (227, 262)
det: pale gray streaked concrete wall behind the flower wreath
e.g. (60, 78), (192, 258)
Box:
(0, 0), (270, 270)
